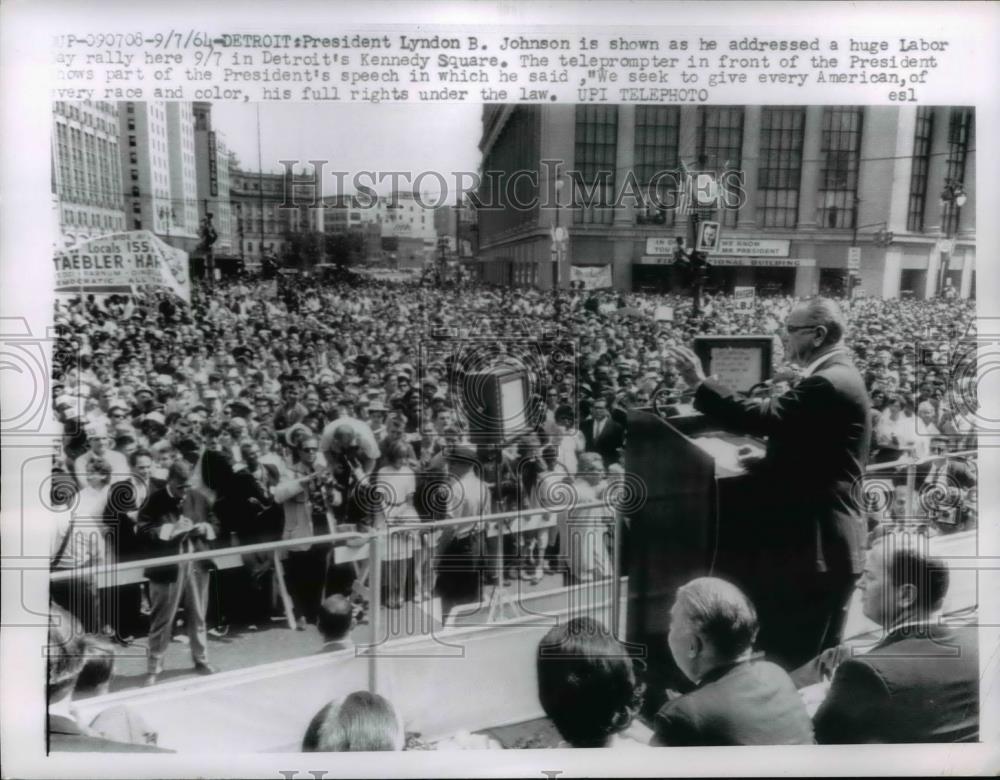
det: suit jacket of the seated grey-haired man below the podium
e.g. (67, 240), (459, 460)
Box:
(651, 661), (813, 746)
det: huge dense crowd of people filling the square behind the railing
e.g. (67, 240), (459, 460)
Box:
(52, 275), (975, 696)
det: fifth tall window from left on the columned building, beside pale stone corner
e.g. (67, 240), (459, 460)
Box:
(816, 106), (863, 228)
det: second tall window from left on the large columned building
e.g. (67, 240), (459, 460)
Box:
(635, 106), (681, 225)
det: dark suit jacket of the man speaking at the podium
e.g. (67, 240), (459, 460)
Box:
(694, 354), (871, 576)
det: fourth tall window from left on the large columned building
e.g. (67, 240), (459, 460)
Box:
(757, 106), (806, 228)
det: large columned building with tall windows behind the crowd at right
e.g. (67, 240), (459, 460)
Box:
(477, 104), (976, 298)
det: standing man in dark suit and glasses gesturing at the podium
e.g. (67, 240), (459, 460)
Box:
(673, 298), (871, 668)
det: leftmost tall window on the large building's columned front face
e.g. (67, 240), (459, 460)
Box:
(571, 105), (618, 224)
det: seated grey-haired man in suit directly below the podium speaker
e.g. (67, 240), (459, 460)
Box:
(650, 577), (813, 746)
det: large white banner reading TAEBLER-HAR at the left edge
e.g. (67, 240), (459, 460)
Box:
(53, 230), (191, 302)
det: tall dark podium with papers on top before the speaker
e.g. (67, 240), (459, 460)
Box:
(625, 410), (765, 715)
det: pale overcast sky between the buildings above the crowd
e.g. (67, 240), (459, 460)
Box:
(212, 103), (482, 195)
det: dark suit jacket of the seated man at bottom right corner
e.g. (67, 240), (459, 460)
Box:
(813, 625), (979, 744)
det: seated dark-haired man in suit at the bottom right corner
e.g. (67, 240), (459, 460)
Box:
(796, 533), (979, 744)
